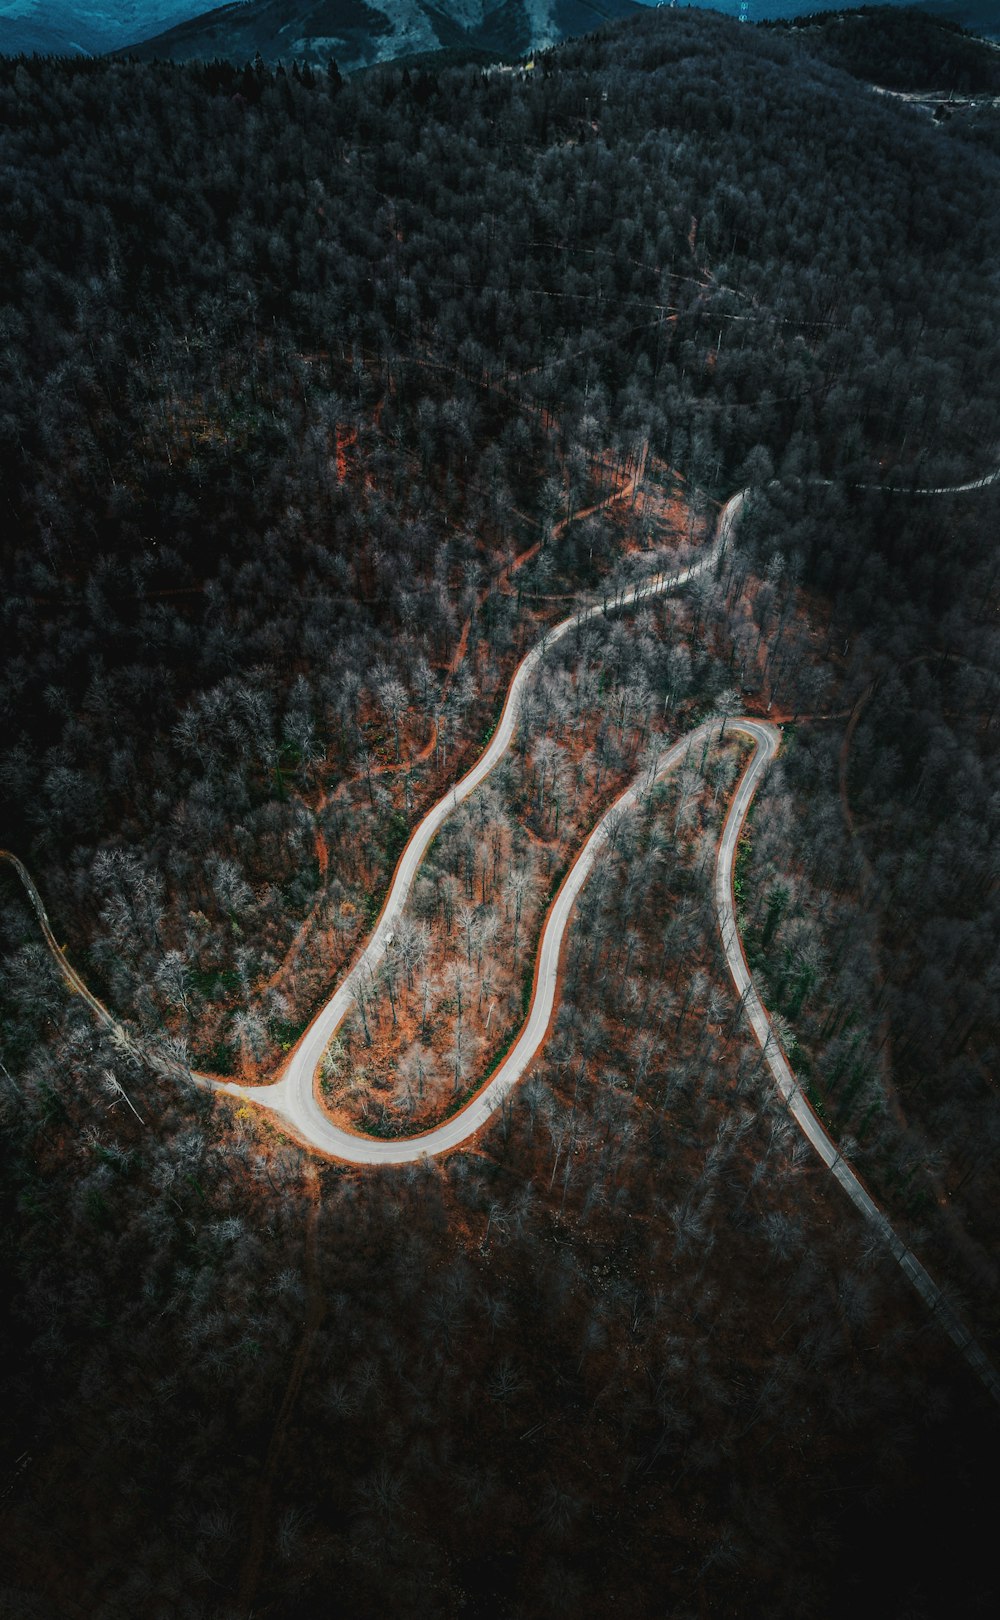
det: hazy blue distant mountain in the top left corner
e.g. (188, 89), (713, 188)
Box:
(0, 0), (203, 57)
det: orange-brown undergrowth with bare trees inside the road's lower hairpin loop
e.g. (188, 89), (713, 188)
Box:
(323, 721), (746, 1136)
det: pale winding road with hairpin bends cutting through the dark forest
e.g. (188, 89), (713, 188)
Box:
(0, 470), (1000, 1403)
